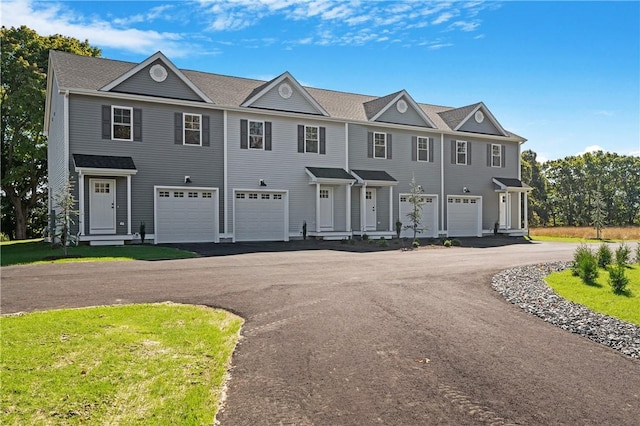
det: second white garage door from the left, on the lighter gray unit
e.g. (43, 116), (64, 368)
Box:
(234, 191), (289, 241)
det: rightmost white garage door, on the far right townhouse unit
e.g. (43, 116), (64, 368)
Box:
(447, 196), (482, 237)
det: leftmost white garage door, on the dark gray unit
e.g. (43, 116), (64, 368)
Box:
(155, 188), (218, 243)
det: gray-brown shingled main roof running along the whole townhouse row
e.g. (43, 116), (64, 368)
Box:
(50, 51), (526, 142)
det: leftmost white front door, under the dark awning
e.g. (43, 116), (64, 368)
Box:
(89, 179), (116, 234)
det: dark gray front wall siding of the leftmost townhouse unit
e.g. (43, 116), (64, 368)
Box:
(69, 95), (224, 234)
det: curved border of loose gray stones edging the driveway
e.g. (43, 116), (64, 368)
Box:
(491, 262), (640, 359)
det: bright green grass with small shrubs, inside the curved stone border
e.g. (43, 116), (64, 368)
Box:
(545, 264), (640, 325)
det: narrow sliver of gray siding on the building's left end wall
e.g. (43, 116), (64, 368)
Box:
(47, 75), (69, 220)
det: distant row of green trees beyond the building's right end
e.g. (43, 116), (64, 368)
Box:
(521, 150), (640, 227)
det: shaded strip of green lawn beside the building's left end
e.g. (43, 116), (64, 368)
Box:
(0, 239), (197, 266)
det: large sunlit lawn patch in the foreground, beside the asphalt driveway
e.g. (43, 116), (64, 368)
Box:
(0, 303), (242, 425)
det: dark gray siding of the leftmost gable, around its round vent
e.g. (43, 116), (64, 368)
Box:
(111, 60), (202, 102)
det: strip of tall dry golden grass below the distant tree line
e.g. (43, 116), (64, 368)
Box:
(529, 226), (640, 242)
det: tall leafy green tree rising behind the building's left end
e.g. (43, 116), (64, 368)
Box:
(0, 25), (101, 239)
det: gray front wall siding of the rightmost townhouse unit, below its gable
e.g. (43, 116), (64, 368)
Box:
(444, 136), (520, 229)
